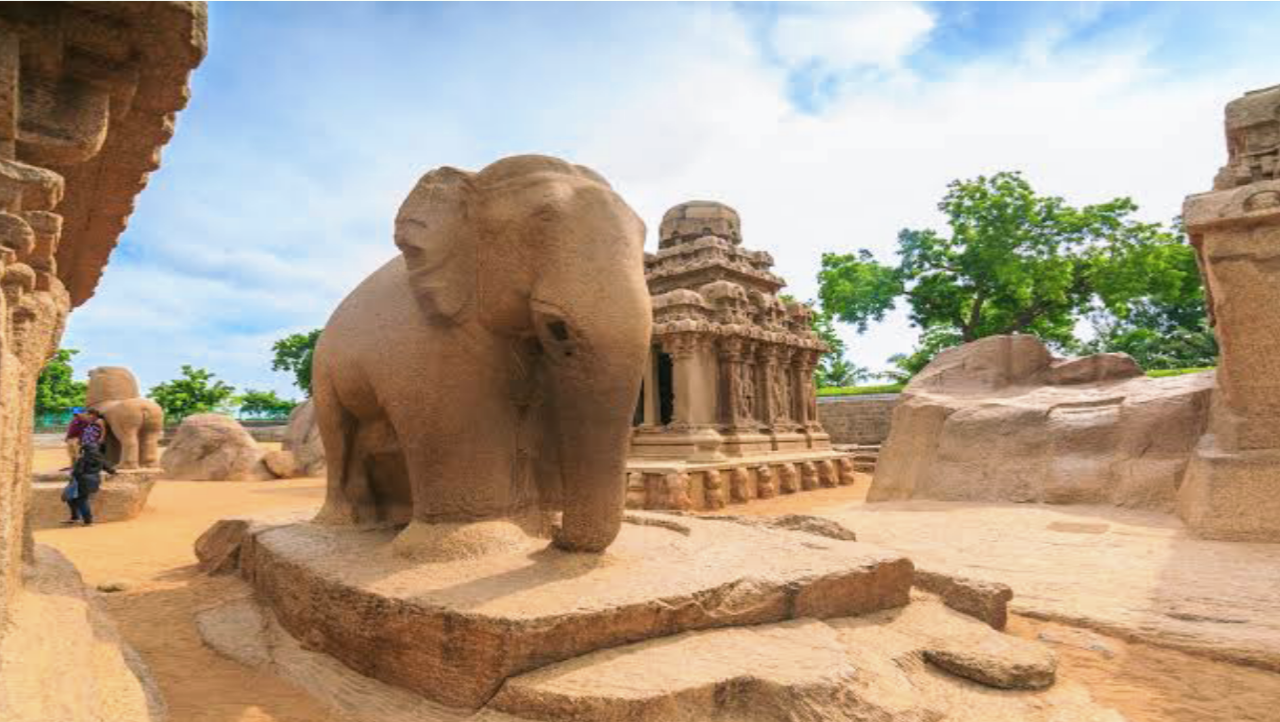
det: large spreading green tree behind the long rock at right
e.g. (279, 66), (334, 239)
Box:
(818, 173), (1199, 376)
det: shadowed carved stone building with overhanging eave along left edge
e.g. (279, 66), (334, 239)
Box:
(0, 3), (206, 721)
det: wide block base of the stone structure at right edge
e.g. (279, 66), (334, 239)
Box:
(1178, 437), (1280, 542)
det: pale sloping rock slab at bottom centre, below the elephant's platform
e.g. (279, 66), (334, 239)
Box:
(490, 599), (1123, 722)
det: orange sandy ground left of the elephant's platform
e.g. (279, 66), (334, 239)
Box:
(36, 466), (334, 722)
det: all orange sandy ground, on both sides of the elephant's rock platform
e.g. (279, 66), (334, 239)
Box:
(27, 444), (1280, 722)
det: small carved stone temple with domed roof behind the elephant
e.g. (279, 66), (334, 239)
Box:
(627, 201), (854, 509)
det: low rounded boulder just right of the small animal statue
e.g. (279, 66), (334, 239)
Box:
(160, 413), (275, 481)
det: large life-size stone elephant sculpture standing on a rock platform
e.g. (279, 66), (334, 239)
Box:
(312, 156), (652, 559)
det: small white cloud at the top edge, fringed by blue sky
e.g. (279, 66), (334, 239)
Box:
(772, 3), (934, 69)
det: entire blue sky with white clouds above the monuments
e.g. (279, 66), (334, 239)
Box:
(63, 3), (1280, 396)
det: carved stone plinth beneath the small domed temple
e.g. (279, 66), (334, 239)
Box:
(627, 449), (855, 511)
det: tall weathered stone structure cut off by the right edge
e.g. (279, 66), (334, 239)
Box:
(1178, 86), (1280, 542)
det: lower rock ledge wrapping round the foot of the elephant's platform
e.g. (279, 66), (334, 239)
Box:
(196, 581), (1124, 722)
